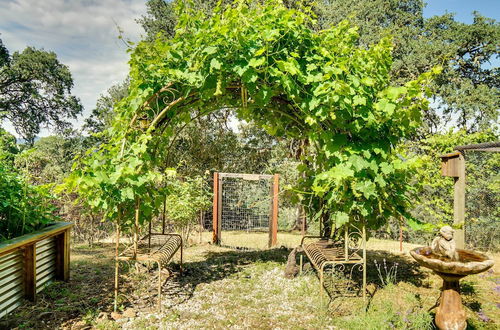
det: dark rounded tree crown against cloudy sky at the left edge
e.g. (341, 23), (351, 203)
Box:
(0, 43), (82, 144)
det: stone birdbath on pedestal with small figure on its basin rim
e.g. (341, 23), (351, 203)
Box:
(410, 226), (493, 330)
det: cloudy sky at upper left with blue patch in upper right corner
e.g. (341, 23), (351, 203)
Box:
(0, 0), (500, 136)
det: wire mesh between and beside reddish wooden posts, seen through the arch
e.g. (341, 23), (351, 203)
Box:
(200, 174), (303, 249)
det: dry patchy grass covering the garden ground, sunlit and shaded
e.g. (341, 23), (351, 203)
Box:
(0, 233), (500, 329)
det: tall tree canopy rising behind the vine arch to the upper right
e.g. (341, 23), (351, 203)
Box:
(138, 0), (500, 136)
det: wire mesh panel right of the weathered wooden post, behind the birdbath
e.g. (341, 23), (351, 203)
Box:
(463, 150), (500, 251)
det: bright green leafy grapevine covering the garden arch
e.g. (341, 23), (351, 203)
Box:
(68, 1), (439, 233)
